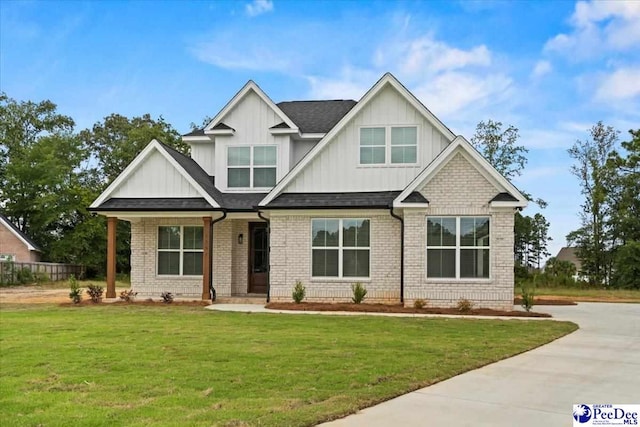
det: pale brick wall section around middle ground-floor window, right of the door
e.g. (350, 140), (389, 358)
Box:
(270, 211), (400, 303)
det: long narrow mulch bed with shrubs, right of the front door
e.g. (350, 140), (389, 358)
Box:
(265, 302), (551, 317)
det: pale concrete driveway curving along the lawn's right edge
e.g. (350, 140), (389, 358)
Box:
(322, 303), (640, 427)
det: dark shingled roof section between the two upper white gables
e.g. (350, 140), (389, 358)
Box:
(276, 99), (357, 133)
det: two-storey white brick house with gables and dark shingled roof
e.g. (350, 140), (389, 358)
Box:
(90, 74), (527, 309)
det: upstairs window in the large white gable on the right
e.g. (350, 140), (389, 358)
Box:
(360, 126), (418, 165)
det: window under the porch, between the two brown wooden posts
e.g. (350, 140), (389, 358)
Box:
(158, 226), (202, 276)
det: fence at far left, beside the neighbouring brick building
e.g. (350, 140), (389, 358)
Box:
(0, 261), (84, 285)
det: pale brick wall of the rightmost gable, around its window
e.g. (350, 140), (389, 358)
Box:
(405, 154), (514, 310)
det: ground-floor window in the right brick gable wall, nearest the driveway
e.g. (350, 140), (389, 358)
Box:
(427, 217), (491, 279)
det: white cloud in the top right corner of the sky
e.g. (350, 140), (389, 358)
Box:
(544, 0), (640, 59)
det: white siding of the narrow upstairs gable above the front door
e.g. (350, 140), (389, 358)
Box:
(212, 92), (291, 192)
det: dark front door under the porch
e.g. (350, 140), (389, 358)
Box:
(249, 222), (269, 294)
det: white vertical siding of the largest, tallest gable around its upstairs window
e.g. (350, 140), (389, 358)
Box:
(283, 86), (450, 193)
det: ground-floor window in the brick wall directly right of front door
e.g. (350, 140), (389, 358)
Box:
(311, 219), (371, 278)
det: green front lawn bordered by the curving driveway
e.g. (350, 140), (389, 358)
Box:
(0, 304), (577, 426)
